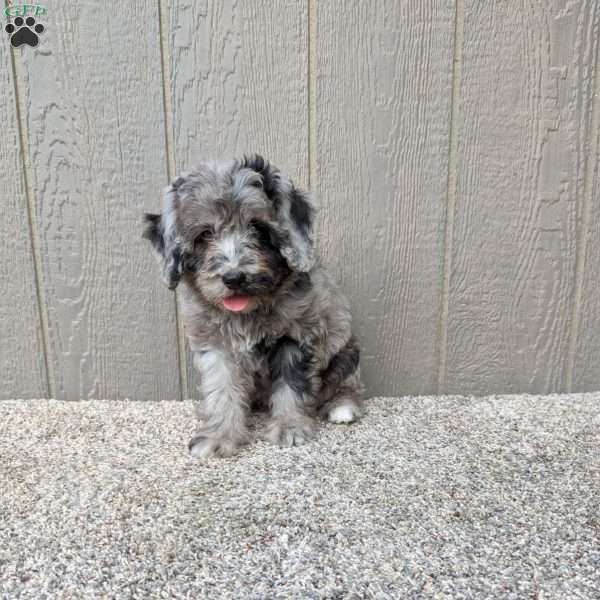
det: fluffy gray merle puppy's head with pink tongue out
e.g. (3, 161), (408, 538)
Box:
(144, 156), (315, 312)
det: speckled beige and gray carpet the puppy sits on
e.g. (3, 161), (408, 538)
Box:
(0, 394), (600, 600)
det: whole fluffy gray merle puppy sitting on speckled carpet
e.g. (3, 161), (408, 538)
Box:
(144, 156), (362, 458)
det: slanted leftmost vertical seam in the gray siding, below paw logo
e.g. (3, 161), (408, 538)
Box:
(10, 47), (55, 398)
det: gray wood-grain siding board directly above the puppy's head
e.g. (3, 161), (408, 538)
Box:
(166, 0), (308, 398)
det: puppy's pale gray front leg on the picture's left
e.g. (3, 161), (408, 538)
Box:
(189, 349), (251, 458)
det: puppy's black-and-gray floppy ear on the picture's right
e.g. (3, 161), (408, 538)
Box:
(243, 155), (316, 272)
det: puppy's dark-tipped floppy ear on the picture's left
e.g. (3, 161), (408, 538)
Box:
(142, 186), (184, 290)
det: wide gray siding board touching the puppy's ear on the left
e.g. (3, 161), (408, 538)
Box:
(16, 0), (180, 400)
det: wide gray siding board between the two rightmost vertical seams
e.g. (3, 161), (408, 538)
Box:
(443, 0), (599, 393)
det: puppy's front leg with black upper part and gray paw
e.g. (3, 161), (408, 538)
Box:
(265, 338), (314, 446)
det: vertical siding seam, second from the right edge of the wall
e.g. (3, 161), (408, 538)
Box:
(437, 0), (465, 394)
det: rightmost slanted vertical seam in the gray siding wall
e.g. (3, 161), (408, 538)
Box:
(566, 18), (600, 392)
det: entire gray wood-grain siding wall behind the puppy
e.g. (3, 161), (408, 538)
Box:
(0, 0), (600, 400)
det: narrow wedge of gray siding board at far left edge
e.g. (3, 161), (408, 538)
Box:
(0, 50), (49, 399)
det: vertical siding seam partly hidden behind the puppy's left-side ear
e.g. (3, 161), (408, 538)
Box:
(158, 0), (188, 400)
